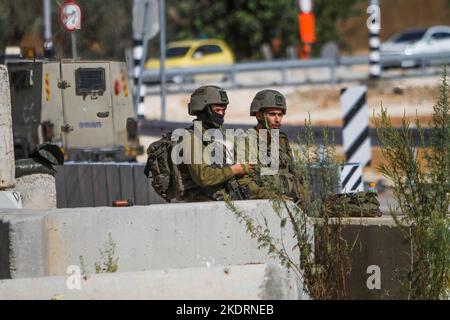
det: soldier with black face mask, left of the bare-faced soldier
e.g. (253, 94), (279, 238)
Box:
(185, 86), (252, 202)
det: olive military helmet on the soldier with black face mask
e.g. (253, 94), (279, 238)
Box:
(188, 86), (230, 116)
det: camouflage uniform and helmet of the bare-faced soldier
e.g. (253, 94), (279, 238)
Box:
(239, 90), (300, 199)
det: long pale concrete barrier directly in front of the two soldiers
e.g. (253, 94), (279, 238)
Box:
(0, 201), (294, 278)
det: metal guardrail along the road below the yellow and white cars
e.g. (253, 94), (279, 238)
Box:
(143, 53), (450, 94)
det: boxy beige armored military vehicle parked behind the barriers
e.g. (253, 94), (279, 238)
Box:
(8, 60), (143, 161)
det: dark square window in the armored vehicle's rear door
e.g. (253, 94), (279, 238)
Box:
(75, 68), (106, 96)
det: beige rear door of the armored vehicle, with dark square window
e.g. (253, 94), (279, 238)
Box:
(60, 62), (114, 148)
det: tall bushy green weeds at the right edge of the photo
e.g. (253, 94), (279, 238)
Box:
(375, 69), (450, 300)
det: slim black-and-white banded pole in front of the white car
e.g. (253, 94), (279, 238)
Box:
(367, 0), (381, 79)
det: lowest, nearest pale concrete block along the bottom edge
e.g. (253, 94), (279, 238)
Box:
(0, 264), (306, 300)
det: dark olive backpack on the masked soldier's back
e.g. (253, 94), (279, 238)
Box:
(144, 133), (196, 202)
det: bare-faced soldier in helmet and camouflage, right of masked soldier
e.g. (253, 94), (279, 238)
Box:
(239, 90), (300, 199)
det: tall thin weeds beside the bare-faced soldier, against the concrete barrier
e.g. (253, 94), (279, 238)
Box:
(226, 119), (351, 299)
